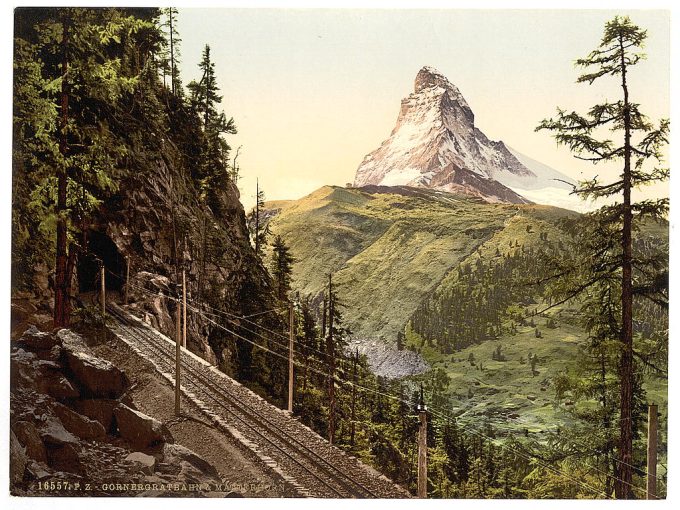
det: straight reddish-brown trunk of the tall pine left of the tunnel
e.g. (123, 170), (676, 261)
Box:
(54, 14), (72, 327)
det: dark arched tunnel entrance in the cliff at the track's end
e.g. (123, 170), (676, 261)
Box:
(78, 230), (125, 292)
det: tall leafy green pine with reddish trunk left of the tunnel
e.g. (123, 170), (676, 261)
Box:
(14, 8), (158, 326)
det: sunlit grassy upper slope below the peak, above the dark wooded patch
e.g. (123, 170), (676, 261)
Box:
(270, 186), (570, 342)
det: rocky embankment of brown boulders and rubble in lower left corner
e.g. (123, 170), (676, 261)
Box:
(10, 326), (233, 496)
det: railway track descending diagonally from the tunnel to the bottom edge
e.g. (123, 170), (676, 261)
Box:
(107, 305), (408, 498)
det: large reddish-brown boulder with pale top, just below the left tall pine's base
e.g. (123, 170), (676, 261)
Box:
(65, 349), (129, 398)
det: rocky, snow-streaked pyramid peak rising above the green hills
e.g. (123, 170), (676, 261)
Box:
(354, 67), (570, 203)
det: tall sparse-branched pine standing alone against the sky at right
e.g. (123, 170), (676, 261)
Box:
(537, 16), (669, 499)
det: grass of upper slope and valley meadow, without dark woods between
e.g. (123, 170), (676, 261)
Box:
(270, 186), (668, 452)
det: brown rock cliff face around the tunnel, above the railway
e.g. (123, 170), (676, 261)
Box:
(81, 144), (268, 363)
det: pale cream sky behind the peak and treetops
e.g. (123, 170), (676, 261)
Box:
(179, 8), (670, 208)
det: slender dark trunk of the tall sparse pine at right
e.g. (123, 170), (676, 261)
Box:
(616, 32), (633, 499)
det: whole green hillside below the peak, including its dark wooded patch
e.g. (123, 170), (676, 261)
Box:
(270, 186), (667, 470)
